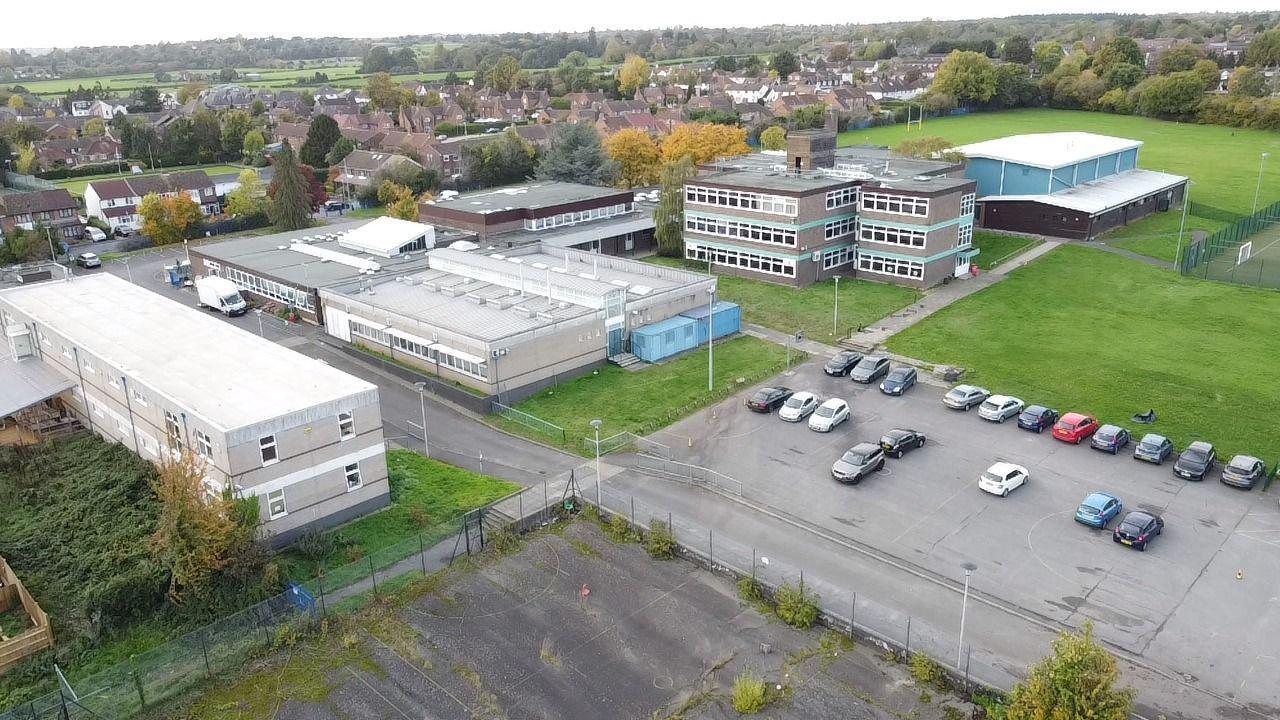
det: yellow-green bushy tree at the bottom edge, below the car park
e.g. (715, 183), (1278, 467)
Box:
(1009, 623), (1137, 720)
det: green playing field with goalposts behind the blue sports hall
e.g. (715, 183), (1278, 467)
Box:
(840, 109), (1280, 261)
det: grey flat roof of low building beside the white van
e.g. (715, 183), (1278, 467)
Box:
(191, 218), (475, 288)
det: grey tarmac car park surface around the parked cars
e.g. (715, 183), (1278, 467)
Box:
(652, 357), (1280, 687)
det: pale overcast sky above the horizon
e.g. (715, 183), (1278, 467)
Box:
(10, 0), (1276, 47)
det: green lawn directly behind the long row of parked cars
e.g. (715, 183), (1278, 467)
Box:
(888, 246), (1280, 462)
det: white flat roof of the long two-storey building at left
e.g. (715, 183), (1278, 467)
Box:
(0, 273), (378, 430)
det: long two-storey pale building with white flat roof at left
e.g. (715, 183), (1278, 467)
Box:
(0, 273), (390, 544)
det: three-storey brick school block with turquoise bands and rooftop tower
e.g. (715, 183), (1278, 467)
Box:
(685, 129), (978, 287)
